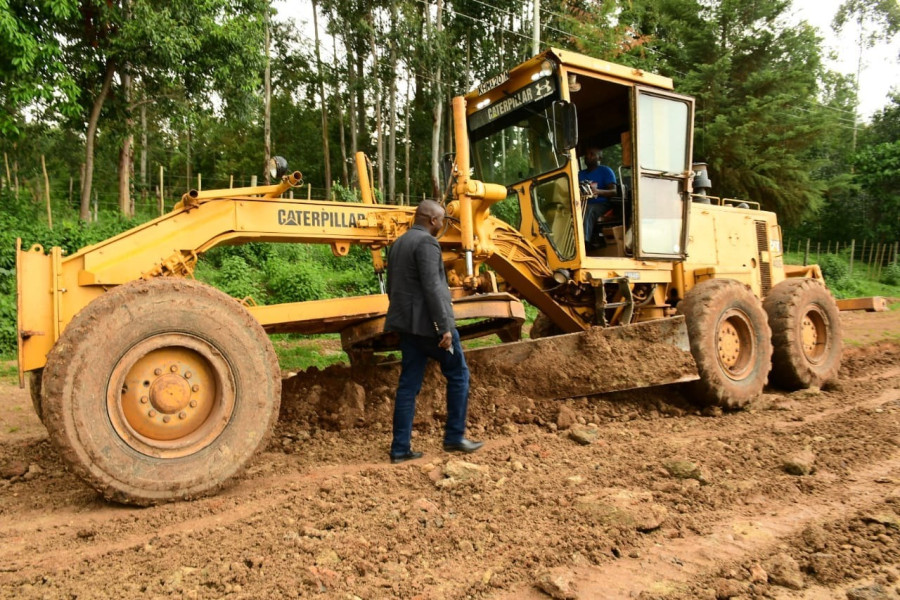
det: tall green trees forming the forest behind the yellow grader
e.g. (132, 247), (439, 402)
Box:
(0, 0), (900, 245)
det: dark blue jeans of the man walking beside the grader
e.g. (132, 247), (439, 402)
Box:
(391, 329), (469, 456)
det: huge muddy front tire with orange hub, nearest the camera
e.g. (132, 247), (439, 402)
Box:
(42, 278), (281, 505)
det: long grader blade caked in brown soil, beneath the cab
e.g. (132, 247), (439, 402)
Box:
(466, 316), (699, 399)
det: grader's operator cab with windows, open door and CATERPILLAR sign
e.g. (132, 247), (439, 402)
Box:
(468, 50), (693, 267)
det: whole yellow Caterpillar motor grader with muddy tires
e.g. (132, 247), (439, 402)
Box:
(17, 49), (841, 505)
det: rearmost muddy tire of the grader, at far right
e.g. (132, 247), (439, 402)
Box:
(763, 278), (841, 390)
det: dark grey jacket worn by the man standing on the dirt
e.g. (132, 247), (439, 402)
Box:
(384, 225), (456, 336)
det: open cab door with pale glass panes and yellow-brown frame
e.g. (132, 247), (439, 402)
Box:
(632, 86), (694, 260)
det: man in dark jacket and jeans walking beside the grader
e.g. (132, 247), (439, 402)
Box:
(384, 200), (484, 463)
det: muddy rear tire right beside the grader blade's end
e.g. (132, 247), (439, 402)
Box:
(678, 279), (772, 409)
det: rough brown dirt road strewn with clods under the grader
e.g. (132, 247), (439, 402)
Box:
(0, 311), (900, 599)
